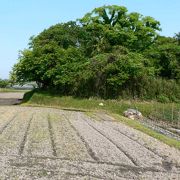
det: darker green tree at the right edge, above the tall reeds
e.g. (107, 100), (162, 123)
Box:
(144, 37), (180, 80)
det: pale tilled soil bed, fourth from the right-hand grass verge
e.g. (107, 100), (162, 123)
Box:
(49, 112), (92, 160)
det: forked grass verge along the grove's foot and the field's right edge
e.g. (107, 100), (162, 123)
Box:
(23, 91), (180, 149)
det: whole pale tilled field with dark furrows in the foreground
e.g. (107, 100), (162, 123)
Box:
(0, 106), (180, 180)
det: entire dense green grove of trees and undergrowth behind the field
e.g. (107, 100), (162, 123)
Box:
(11, 5), (180, 101)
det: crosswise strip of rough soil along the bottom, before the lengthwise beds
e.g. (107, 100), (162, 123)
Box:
(0, 157), (179, 180)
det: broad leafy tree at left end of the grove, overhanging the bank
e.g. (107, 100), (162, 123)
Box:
(12, 22), (87, 88)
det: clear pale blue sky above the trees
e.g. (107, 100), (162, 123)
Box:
(0, 0), (180, 78)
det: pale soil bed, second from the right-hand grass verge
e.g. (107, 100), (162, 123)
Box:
(83, 116), (163, 166)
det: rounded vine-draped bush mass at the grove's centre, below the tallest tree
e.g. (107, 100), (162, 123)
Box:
(79, 50), (154, 98)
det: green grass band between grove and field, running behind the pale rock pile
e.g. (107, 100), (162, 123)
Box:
(24, 91), (180, 126)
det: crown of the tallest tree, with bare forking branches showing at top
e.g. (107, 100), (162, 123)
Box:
(79, 5), (160, 53)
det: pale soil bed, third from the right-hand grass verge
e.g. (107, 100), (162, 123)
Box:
(70, 113), (134, 165)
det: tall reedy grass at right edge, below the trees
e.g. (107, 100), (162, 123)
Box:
(120, 77), (180, 103)
